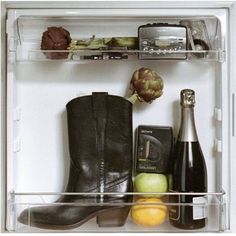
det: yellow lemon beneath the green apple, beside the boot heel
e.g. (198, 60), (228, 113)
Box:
(131, 198), (167, 226)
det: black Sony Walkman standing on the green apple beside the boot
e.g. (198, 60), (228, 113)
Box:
(135, 125), (173, 174)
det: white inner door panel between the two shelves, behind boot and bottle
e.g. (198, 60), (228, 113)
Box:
(9, 62), (220, 192)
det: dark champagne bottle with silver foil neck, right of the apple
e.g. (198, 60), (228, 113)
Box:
(169, 89), (207, 229)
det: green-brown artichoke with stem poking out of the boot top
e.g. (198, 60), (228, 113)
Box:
(128, 68), (164, 104)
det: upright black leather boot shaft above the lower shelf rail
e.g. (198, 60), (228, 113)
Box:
(67, 93), (133, 192)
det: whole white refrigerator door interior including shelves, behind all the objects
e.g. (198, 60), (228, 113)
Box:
(7, 9), (229, 232)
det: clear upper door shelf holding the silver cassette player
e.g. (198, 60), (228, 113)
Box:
(8, 12), (225, 64)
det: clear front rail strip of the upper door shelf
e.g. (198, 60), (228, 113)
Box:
(10, 49), (225, 63)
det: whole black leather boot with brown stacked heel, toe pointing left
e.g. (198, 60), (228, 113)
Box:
(18, 93), (133, 229)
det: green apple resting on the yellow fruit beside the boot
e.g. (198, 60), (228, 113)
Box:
(134, 173), (168, 197)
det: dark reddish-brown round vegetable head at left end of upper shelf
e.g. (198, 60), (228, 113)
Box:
(41, 27), (71, 59)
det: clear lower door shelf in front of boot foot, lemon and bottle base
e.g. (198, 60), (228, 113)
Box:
(8, 192), (226, 232)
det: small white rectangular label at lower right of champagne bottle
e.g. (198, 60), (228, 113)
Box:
(193, 197), (207, 220)
